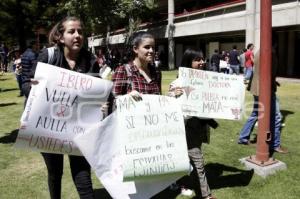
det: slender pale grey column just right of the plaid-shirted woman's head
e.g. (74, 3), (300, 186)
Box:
(167, 0), (175, 70)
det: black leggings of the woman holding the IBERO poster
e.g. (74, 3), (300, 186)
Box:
(42, 153), (94, 199)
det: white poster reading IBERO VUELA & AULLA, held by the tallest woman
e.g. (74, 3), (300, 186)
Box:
(15, 63), (112, 155)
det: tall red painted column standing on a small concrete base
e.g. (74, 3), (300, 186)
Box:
(256, 0), (272, 162)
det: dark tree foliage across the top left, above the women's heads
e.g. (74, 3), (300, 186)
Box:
(0, 0), (156, 51)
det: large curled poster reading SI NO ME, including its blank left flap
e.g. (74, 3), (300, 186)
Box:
(74, 95), (190, 198)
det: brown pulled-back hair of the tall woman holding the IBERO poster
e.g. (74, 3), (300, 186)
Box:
(48, 16), (84, 46)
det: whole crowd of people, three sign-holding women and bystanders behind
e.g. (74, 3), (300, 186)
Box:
(0, 17), (287, 199)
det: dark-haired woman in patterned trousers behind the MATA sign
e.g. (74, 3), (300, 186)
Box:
(169, 49), (218, 199)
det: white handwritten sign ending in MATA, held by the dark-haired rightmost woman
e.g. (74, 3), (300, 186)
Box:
(178, 67), (245, 120)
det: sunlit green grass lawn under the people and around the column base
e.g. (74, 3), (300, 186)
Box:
(0, 71), (300, 199)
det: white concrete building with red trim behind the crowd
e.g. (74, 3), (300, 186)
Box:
(88, 0), (300, 78)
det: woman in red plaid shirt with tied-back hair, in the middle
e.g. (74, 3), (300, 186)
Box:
(112, 31), (160, 98)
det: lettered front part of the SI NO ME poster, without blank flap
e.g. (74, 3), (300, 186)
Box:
(116, 95), (189, 178)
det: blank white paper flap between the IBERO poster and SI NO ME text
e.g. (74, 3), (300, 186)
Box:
(74, 113), (131, 198)
